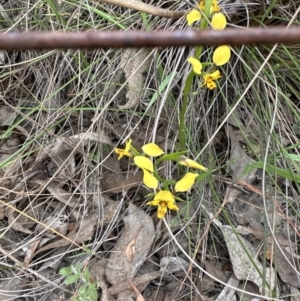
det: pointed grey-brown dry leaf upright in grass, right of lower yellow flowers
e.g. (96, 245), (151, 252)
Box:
(226, 126), (256, 203)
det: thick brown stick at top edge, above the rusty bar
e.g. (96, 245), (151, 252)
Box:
(100, 0), (186, 19)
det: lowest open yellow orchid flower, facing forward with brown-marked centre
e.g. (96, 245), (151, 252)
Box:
(147, 190), (179, 218)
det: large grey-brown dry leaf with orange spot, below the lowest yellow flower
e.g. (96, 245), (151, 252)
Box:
(106, 203), (155, 285)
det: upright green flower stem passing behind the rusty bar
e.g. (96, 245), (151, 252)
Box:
(179, 0), (212, 150)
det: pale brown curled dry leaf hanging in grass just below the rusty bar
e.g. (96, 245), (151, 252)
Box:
(119, 48), (151, 109)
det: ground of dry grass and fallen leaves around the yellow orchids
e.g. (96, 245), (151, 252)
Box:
(0, 0), (300, 300)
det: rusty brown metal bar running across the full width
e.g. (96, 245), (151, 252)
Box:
(0, 27), (300, 50)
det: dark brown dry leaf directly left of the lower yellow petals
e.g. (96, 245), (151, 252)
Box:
(101, 171), (143, 193)
